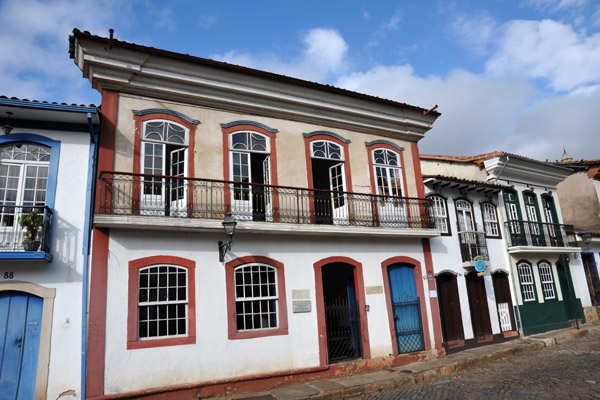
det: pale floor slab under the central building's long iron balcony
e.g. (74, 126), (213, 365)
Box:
(94, 214), (440, 238)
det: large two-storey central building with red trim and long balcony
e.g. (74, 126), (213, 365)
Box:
(70, 30), (444, 397)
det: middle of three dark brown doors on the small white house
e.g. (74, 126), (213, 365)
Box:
(465, 272), (492, 342)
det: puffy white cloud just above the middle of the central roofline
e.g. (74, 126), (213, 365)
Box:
(212, 28), (348, 82)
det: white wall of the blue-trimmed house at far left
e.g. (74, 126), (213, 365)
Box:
(0, 129), (90, 399)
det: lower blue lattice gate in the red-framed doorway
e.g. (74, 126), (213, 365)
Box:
(392, 297), (424, 353)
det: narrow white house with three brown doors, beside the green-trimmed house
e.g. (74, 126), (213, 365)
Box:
(421, 154), (518, 353)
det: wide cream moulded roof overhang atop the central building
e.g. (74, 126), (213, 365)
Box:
(70, 30), (440, 141)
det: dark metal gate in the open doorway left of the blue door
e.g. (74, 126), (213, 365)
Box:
(325, 296), (361, 363)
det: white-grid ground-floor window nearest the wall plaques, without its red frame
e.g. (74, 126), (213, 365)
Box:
(234, 264), (278, 332)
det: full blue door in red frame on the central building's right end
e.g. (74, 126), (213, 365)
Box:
(388, 264), (424, 353)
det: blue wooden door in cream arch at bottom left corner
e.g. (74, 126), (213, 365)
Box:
(0, 292), (44, 400)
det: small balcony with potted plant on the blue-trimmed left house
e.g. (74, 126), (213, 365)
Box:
(0, 205), (52, 261)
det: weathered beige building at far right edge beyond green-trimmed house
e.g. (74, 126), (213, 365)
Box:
(557, 153), (600, 312)
